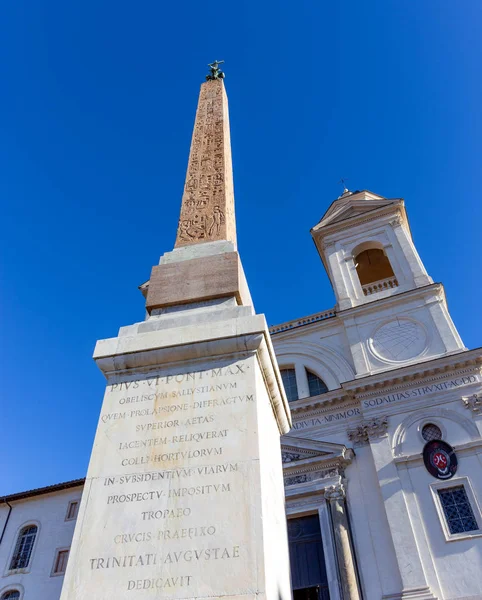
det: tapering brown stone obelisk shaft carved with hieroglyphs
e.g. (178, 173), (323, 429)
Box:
(176, 80), (236, 246)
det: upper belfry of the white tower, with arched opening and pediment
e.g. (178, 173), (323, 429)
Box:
(311, 190), (433, 310)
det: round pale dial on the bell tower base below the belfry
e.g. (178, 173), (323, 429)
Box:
(371, 319), (427, 362)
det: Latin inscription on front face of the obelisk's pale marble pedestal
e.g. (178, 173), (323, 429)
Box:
(72, 359), (259, 598)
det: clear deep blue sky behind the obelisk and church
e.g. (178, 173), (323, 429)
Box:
(0, 0), (482, 494)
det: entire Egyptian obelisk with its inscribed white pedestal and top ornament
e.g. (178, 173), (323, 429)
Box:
(61, 63), (291, 600)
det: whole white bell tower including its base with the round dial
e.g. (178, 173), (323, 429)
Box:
(311, 189), (465, 377)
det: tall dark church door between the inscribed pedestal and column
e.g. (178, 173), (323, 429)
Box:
(288, 515), (330, 600)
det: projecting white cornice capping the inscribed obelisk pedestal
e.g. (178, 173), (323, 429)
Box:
(94, 307), (291, 434)
